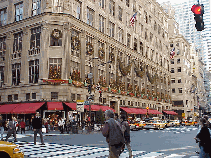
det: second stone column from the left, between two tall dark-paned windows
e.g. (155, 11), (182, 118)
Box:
(20, 27), (30, 85)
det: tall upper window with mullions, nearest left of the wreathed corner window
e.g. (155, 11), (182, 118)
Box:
(30, 27), (41, 49)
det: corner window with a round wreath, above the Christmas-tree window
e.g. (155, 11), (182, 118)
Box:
(50, 29), (62, 46)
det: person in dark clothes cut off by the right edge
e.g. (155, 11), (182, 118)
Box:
(194, 118), (211, 158)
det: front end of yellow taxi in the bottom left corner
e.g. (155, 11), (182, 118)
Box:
(0, 141), (24, 158)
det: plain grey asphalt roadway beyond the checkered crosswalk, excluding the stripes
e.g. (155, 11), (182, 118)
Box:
(13, 126), (199, 157)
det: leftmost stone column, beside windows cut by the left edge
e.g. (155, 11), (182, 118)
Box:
(4, 32), (14, 86)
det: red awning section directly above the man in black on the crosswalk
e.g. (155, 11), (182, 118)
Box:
(11, 102), (45, 114)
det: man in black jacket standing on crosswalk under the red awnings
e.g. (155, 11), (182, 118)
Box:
(32, 112), (45, 145)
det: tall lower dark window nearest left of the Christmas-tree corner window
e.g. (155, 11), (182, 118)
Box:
(29, 59), (39, 83)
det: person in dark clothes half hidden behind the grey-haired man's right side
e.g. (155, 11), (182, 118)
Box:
(121, 115), (132, 158)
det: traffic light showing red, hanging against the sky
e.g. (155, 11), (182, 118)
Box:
(191, 4), (204, 31)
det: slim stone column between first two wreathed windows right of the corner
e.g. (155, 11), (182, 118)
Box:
(81, 31), (86, 82)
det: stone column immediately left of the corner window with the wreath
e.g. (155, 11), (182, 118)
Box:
(39, 23), (50, 82)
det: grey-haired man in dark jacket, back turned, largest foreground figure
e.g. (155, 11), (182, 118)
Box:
(101, 110), (124, 158)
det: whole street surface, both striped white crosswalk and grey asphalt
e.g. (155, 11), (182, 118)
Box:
(5, 126), (199, 158)
